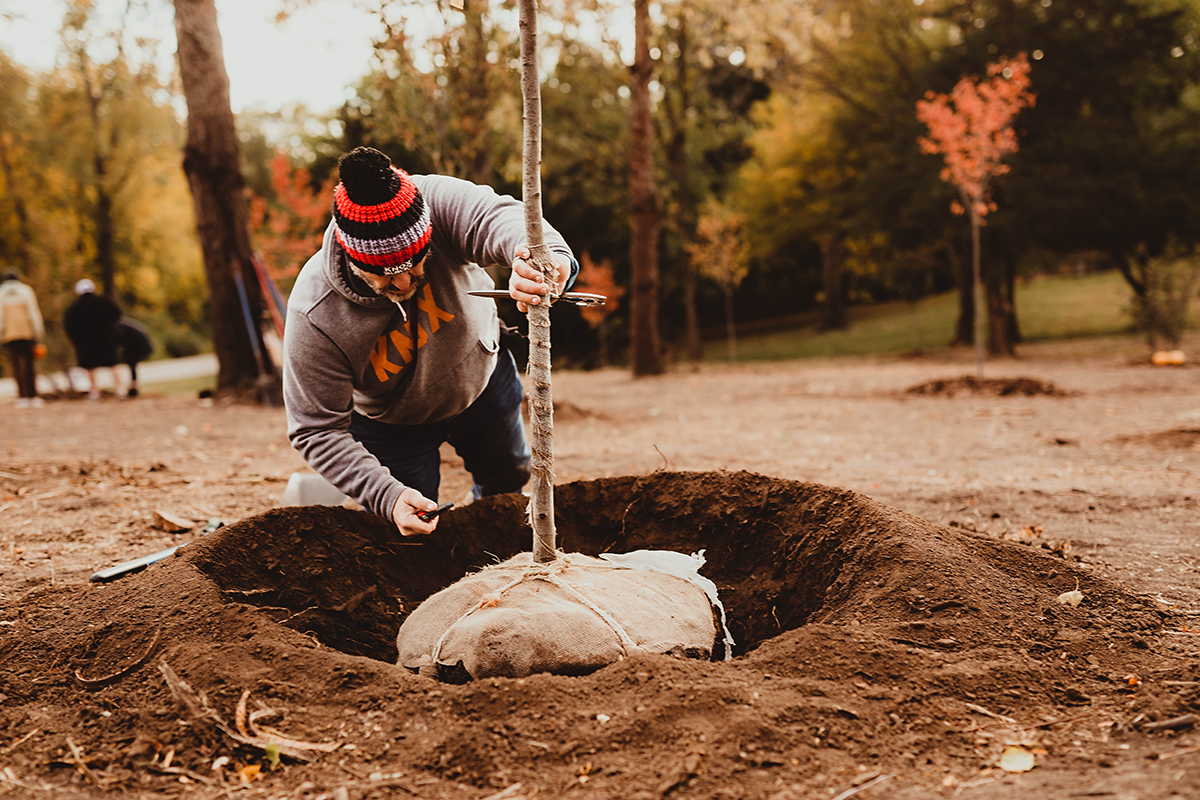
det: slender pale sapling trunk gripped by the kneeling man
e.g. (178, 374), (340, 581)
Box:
(521, 0), (558, 564)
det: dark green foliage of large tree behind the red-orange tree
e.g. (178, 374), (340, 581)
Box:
(919, 0), (1200, 347)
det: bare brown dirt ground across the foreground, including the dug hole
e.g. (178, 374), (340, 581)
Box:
(0, 345), (1200, 800)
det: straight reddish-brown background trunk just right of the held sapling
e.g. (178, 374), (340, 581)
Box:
(629, 0), (665, 375)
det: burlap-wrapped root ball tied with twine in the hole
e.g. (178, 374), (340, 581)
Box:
(396, 551), (732, 682)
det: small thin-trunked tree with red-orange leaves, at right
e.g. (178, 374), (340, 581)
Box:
(917, 53), (1037, 379)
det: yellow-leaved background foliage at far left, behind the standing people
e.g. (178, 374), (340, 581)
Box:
(0, 1), (209, 369)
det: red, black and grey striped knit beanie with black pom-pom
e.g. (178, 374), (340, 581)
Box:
(334, 148), (432, 275)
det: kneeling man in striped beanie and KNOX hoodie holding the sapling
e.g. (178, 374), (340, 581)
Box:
(283, 148), (578, 536)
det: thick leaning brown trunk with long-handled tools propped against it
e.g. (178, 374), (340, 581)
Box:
(174, 0), (275, 392)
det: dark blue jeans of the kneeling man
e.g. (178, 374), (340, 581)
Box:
(350, 349), (532, 501)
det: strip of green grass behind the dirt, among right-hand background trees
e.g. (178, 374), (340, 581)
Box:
(704, 271), (1200, 361)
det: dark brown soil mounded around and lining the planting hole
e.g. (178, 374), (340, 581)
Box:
(0, 473), (1200, 799)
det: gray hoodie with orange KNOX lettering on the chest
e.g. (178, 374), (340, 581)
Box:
(283, 175), (571, 517)
